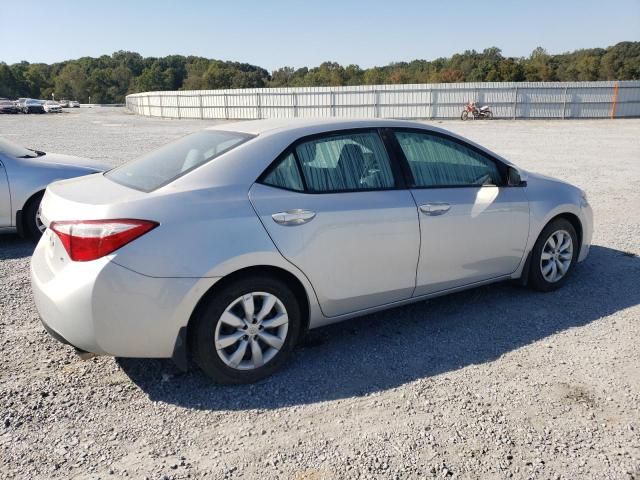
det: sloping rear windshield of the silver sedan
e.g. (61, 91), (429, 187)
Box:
(105, 130), (253, 192)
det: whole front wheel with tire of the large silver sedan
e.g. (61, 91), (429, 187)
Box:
(529, 218), (580, 292)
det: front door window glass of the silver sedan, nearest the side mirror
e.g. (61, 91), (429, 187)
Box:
(395, 132), (502, 187)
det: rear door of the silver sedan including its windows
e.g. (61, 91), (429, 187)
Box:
(249, 130), (420, 317)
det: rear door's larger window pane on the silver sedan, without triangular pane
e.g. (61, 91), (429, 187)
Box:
(296, 132), (394, 192)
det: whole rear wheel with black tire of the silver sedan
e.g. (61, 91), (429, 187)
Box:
(191, 275), (301, 384)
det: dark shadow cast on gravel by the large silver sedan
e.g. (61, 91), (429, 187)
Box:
(118, 246), (640, 410)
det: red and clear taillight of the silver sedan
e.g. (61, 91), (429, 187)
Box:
(49, 219), (158, 262)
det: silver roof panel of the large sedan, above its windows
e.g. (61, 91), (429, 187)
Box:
(207, 118), (450, 137)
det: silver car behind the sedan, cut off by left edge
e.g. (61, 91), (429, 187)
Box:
(0, 137), (109, 240)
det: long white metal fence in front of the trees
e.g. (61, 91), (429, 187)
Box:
(126, 81), (640, 119)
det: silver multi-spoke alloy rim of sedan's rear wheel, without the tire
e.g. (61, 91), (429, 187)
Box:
(214, 292), (289, 370)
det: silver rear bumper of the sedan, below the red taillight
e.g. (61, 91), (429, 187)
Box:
(31, 235), (220, 358)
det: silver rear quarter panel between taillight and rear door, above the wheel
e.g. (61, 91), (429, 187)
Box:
(108, 185), (323, 324)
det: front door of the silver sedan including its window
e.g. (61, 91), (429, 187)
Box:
(394, 129), (529, 296)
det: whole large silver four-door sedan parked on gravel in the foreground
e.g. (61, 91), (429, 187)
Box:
(31, 119), (593, 383)
